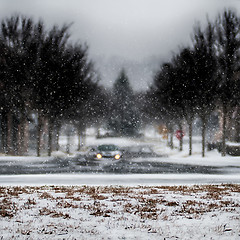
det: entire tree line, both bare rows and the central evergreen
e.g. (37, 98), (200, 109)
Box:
(0, 10), (240, 156)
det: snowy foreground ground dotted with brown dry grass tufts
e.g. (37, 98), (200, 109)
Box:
(0, 184), (240, 240)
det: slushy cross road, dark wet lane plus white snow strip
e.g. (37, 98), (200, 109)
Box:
(0, 155), (240, 185)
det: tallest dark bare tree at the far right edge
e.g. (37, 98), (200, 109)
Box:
(217, 10), (240, 156)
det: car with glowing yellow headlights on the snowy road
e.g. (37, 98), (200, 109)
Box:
(87, 144), (122, 160)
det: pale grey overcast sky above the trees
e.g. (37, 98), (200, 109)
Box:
(0, 0), (240, 89)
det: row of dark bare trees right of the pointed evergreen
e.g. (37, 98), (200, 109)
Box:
(149, 9), (240, 156)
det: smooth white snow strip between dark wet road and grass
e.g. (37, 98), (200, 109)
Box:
(0, 174), (240, 186)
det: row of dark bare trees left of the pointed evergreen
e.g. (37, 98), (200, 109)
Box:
(0, 15), (101, 156)
